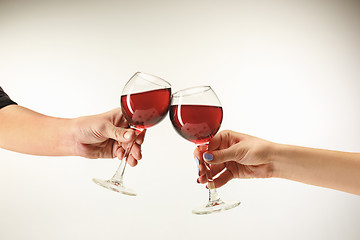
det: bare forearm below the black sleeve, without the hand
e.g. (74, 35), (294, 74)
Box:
(0, 105), (74, 156)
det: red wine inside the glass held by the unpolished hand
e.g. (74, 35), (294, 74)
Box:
(121, 88), (171, 128)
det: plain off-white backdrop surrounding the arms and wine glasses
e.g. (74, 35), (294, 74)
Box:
(0, 0), (360, 240)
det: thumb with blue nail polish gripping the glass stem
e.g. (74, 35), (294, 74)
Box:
(203, 144), (240, 164)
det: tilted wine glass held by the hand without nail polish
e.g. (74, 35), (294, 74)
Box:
(93, 72), (171, 196)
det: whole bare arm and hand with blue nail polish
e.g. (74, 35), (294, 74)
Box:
(194, 130), (360, 195)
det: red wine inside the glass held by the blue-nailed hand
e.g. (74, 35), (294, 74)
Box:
(170, 105), (223, 144)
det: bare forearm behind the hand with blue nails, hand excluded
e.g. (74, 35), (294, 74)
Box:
(273, 144), (360, 195)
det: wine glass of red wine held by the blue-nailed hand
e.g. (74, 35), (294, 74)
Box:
(170, 86), (240, 214)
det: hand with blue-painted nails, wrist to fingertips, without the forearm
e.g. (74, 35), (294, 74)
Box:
(194, 130), (272, 187)
